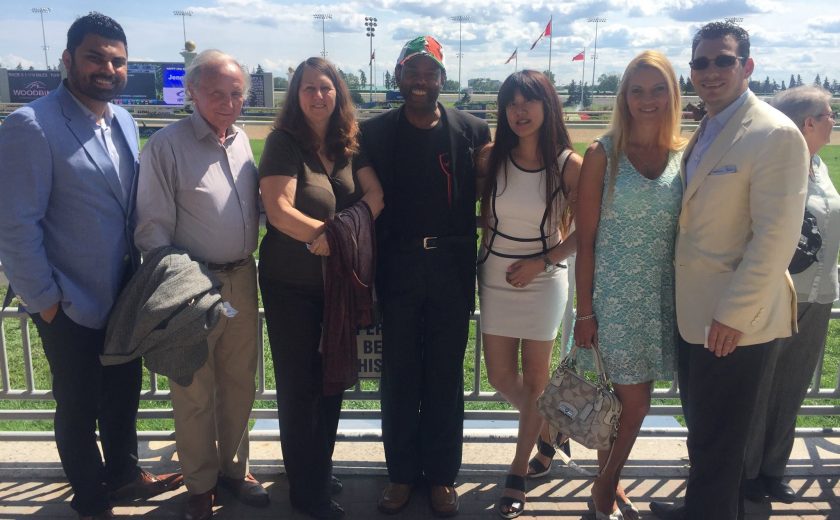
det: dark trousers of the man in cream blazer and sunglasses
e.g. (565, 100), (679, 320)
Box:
(677, 337), (773, 520)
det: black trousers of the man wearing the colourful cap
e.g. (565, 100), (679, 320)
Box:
(379, 249), (475, 486)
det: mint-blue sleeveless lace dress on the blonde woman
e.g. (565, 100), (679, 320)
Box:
(586, 137), (682, 385)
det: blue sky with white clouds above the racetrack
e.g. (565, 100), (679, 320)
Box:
(0, 0), (840, 86)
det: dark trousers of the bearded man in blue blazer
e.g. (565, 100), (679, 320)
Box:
(32, 309), (142, 516)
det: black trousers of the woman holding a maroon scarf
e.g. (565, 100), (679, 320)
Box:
(260, 276), (342, 508)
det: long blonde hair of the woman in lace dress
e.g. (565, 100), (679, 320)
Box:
(605, 51), (687, 200)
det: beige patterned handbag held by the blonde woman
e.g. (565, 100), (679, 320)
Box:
(537, 346), (621, 450)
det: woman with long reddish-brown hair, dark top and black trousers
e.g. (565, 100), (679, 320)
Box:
(259, 58), (383, 518)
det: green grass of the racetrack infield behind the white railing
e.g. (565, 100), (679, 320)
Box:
(0, 140), (840, 431)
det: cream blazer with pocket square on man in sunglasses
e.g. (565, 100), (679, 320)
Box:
(675, 93), (808, 345)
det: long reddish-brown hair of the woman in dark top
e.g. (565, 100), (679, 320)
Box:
(274, 57), (359, 161)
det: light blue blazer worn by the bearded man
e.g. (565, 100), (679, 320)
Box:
(0, 85), (139, 329)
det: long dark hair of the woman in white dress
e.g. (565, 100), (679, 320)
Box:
(481, 70), (573, 234)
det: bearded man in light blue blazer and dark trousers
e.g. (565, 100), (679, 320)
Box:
(0, 13), (181, 518)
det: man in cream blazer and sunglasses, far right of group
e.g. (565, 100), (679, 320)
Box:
(651, 22), (808, 520)
